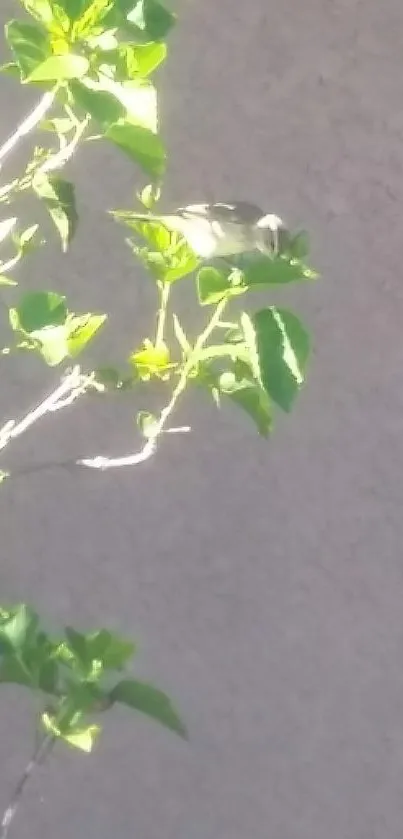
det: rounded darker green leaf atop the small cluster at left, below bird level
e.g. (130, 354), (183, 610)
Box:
(10, 291), (67, 334)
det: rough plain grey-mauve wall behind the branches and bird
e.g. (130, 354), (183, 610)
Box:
(0, 0), (403, 839)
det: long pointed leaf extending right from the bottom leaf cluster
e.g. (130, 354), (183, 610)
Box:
(110, 679), (187, 737)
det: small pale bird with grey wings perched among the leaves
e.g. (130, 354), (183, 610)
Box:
(119, 201), (288, 259)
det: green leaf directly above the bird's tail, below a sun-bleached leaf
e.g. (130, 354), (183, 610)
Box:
(105, 123), (165, 177)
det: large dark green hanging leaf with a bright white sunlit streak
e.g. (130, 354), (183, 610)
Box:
(251, 306), (309, 412)
